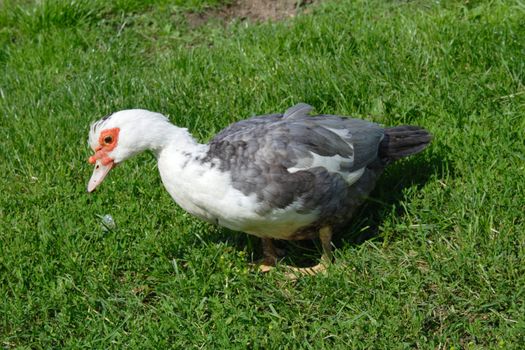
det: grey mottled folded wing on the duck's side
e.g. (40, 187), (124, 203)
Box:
(206, 104), (383, 211)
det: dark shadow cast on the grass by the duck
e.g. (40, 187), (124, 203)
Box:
(207, 149), (453, 267)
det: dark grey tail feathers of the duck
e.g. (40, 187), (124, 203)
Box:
(379, 125), (432, 163)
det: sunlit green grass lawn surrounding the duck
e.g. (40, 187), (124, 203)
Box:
(0, 0), (525, 349)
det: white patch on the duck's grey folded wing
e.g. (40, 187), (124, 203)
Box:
(288, 152), (365, 186)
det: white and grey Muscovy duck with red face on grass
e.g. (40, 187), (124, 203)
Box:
(87, 103), (432, 275)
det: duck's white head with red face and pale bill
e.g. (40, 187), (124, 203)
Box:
(87, 109), (173, 192)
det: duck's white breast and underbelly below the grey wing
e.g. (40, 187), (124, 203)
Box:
(158, 151), (318, 239)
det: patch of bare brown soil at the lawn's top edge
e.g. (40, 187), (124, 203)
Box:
(187, 0), (316, 27)
